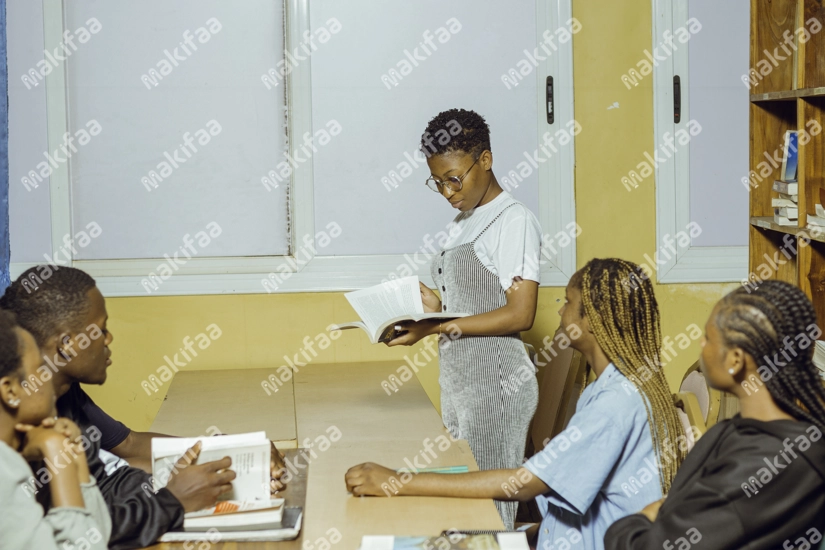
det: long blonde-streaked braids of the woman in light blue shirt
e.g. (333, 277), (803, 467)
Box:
(571, 258), (687, 494)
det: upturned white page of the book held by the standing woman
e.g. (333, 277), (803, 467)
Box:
(346, 275), (424, 334)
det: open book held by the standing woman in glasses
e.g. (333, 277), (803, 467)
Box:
(332, 275), (469, 344)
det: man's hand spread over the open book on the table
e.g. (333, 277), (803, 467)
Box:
(166, 441), (235, 512)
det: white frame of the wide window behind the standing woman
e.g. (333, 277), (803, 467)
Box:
(11, 0), (576, 296)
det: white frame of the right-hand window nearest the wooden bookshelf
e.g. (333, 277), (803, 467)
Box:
(652, 0), (748, 284)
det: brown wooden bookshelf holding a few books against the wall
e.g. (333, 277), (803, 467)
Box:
(749, 0), (825, 334)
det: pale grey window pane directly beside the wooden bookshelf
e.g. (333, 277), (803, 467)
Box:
(674, 0), (750, 246)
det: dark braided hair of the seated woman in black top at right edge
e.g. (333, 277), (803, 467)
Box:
(715, 280), (825, 431)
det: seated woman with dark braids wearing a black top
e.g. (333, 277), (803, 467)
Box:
(605, 281), (825, 550)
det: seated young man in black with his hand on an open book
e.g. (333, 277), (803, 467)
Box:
(0, 266), (282, 549)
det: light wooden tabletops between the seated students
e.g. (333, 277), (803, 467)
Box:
(145, 362), (503, 550)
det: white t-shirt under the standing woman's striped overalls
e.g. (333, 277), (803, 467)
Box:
(444, 191), (541, 290)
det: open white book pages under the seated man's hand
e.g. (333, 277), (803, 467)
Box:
(152, 432), (272, 502)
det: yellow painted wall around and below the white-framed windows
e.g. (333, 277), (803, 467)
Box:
(83, 0), (737, 430)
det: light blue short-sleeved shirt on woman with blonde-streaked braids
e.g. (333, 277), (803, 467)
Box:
(525, 363), (662, 550)
